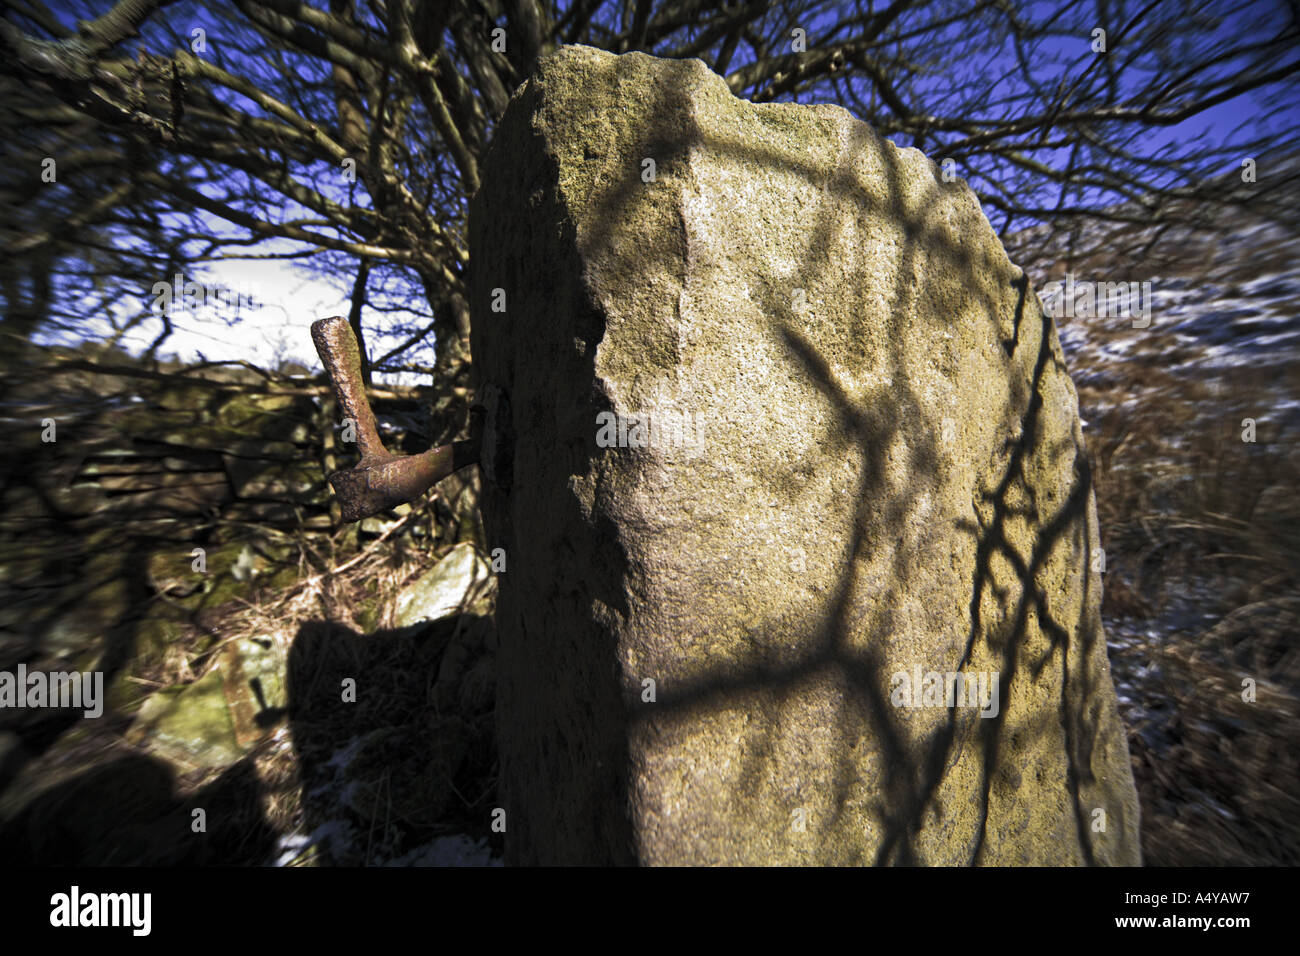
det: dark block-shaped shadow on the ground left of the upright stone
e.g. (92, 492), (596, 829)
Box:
(289, 614), (497, 865)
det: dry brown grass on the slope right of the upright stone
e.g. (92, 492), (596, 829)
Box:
(1080, 348), (1300, 866)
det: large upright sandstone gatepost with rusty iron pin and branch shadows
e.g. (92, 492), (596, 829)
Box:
(469, 47), (1139, 865)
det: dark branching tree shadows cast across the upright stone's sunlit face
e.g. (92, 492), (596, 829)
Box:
(476, 48), (1128, 865)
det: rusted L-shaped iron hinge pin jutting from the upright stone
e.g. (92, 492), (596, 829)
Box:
(312, 316), (482, 522)
